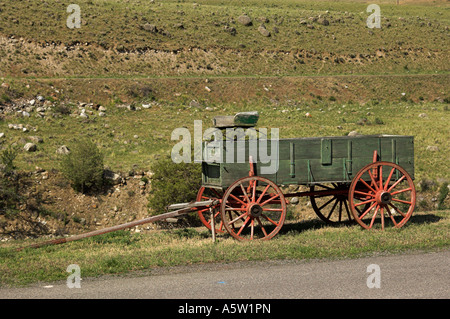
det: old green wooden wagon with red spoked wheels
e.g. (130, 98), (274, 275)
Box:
(193, 114), (415, 240)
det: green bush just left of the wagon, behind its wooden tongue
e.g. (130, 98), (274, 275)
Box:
(148, 158), (202, 215)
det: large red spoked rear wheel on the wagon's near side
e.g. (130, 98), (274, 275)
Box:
(348, 162), (416, 229)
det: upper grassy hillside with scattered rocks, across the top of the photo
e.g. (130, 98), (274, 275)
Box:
(0, 0), (449, 77)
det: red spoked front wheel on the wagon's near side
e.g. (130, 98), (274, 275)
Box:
(220, 176), (286, 240)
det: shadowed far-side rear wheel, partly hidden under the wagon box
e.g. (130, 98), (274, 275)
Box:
(309, 183), (353, 225)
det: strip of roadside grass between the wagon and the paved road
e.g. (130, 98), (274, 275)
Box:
(0, 211), (450, 287)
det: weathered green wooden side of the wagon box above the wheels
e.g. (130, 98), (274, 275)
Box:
(202, 135), (414, 188)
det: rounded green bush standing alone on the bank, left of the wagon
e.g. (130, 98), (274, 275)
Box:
(61, 140), (104, 193)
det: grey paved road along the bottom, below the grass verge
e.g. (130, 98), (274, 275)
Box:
(0, 250), (450, 299)
